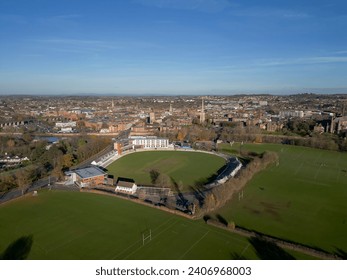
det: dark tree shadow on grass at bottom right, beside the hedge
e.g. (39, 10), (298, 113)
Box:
(248, 237), (295, 260)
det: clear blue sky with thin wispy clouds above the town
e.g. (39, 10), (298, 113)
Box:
(0, 0), (347, 95)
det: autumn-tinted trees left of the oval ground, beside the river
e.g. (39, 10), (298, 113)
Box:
(0, 136), (111, 192)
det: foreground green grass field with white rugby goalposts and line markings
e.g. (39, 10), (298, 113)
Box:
(0, 191), (318, 260)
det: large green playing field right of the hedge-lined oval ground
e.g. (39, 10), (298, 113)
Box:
(218, 144), (347, 255)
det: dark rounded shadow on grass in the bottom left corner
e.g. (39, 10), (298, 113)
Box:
(0, 235), (34, 260)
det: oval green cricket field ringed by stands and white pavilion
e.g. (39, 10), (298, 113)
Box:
(107, 151), (225, 188)
